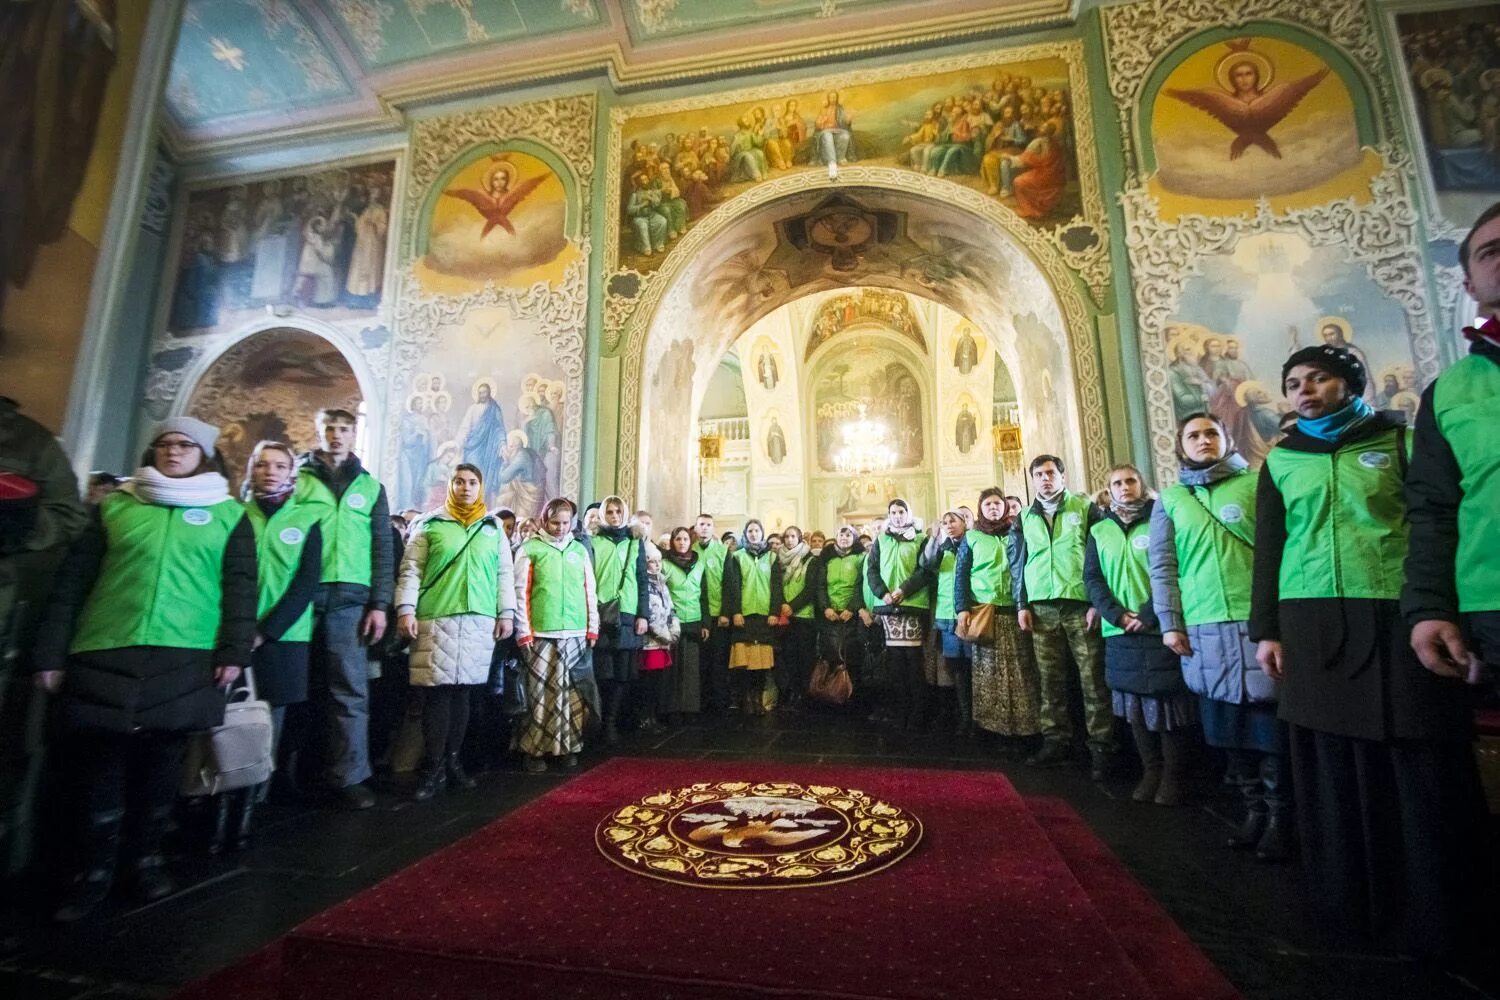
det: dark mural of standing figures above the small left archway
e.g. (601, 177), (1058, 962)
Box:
(167, 160), (396, 336)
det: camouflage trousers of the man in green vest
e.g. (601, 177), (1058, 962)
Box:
(1031, 601), (1115, 751)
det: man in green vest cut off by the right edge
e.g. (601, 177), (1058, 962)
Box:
(1401, 202), (1500, 679)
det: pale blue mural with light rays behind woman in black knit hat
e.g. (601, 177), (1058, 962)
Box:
(1163, 232), (1421, 465)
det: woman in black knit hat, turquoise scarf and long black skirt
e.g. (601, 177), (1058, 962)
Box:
(1251, 345), (1485, 958)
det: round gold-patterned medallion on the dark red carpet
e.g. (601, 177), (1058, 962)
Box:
(594, 781), (923, 889)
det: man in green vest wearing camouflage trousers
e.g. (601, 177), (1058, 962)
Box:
(1010, 454), (1115, 781)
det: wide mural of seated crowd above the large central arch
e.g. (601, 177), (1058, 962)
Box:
(620, 58), (1082, 271)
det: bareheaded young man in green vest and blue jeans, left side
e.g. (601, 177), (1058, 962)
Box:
(297, 409), (396, 810)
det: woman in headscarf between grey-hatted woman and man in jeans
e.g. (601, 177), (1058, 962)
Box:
(209, 441), (327, 855)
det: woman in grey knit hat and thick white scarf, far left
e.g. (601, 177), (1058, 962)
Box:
(33, 417), (257, 921)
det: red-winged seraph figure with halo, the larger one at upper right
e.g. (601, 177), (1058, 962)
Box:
(1167, 37), (1329, 160)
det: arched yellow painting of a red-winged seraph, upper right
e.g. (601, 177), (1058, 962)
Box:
(1145, 34), (1380, 219)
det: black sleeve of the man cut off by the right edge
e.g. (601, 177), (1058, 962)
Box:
(1401, 382), (1464, 625)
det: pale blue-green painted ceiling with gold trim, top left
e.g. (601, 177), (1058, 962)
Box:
(167, 0), (1073, 150)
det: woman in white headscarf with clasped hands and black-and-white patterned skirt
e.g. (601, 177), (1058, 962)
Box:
(866, 498), (932, 729)
